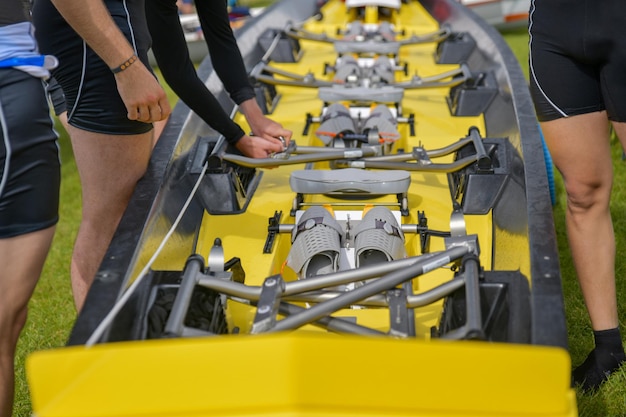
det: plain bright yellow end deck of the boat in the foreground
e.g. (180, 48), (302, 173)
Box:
(28, 333), (576, 417)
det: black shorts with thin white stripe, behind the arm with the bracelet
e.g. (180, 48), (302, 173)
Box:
(33, 0), (152, 135)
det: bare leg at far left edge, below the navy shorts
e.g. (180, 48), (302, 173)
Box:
(0, 227), (55, 417)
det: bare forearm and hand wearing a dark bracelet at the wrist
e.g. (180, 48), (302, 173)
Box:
(52, 0), (171, 123)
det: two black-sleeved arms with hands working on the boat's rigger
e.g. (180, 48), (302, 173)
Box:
(146, 0), (292, 158)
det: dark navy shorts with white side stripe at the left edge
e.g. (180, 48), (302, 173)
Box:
(0, 68), (61, 238)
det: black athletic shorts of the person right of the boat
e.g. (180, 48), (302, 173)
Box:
(529, 0), (626, 122)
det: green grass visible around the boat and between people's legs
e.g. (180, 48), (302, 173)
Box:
(14, 20), (626, 417)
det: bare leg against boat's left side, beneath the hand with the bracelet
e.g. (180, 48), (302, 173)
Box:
(69, 126), (153, 311)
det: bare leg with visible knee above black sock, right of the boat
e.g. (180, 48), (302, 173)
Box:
(541, 112), (618, 330)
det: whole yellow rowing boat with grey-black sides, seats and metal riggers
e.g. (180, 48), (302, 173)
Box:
(27, 0), (577, 417)
